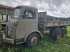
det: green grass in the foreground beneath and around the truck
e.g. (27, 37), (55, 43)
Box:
(0, 26), (70, 52)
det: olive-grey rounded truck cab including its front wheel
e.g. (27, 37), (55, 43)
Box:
(1, 6), (41, 46)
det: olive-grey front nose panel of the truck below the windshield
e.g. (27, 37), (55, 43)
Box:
(7, 19), (18, 38)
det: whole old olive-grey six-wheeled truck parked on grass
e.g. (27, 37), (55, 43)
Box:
(1, 6), (70, 47)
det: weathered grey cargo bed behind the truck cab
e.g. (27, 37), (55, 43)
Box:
(38, 12), (70, 32)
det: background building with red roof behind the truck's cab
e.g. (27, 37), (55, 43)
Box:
(0, 4), (14, 21)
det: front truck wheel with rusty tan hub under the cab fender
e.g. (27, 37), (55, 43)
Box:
(26, 33), (41, 47)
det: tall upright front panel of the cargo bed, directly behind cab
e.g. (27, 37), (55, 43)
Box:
(38, 12), (46, 33)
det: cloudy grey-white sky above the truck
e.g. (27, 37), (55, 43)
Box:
(0, 0), (70, 17)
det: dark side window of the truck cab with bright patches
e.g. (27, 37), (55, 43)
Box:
(22, 11), (36, 19)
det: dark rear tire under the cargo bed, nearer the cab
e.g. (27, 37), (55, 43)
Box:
(51, 28), (62, 40)
